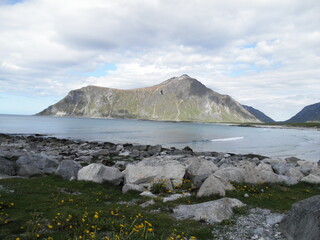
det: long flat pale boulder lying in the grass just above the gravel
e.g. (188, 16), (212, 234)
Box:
(173, 198), (245, 223)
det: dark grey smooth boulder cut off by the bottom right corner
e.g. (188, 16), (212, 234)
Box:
(279, 195), (320, 240)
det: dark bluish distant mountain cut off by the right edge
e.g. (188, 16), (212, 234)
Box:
(285, 102), (320, 123)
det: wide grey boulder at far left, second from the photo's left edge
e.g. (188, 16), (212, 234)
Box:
(16, 153), (59, 173)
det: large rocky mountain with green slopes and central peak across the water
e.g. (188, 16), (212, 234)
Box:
(37, 75), (259, 122)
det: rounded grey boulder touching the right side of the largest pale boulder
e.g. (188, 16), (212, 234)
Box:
(187, 157), (218, 177)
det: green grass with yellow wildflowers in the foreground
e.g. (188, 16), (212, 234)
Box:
(0, 176), (320, 240)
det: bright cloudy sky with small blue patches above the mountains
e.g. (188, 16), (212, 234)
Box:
(0, 0), (320, 121)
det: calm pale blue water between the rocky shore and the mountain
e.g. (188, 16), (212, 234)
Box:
(0, 115), (320, 161)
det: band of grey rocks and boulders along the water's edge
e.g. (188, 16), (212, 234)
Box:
(0, 134), (320, 240)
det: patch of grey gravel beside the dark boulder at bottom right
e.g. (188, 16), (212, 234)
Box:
(213, 208), (287, 240)
